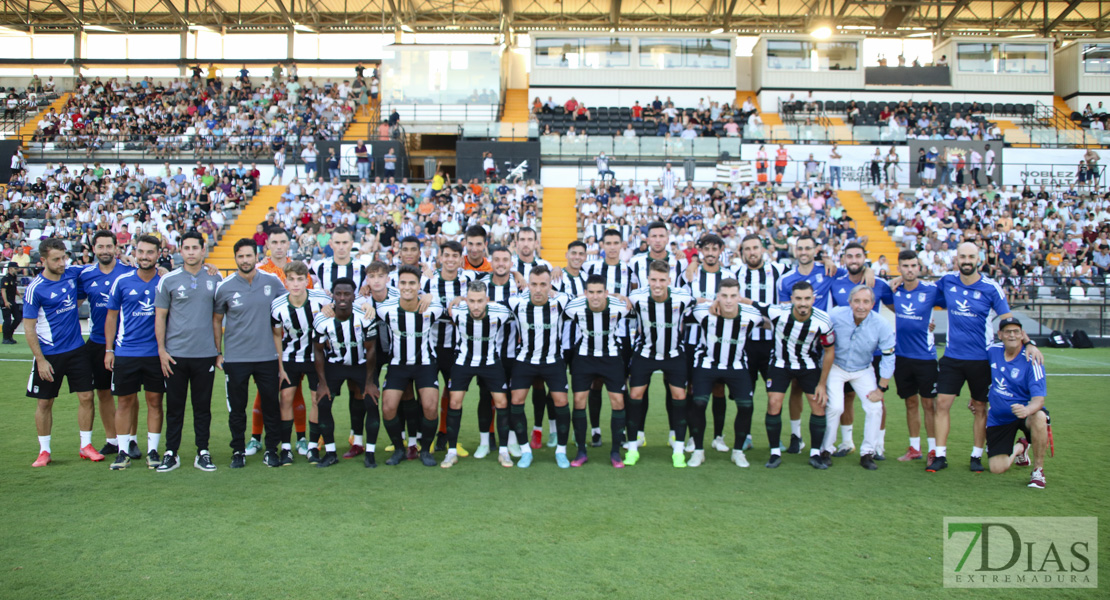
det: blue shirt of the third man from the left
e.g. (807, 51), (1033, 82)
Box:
(108, 272), (160, 356)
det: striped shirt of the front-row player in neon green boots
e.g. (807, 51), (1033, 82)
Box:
(628, 287), (695, 360)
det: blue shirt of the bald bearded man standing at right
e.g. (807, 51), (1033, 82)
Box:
(937, 273), (1010, 360)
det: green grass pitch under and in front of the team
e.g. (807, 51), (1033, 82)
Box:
(0, 345), (1110, 599)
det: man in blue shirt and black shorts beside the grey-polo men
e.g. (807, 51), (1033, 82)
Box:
(104, 235), (164, 470)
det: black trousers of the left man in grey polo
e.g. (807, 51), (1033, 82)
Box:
(165, 356), (215, 454)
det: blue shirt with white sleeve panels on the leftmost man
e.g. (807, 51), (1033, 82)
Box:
(23, 266), (84, 356)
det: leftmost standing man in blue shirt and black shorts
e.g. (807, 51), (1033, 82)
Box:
(23, 237), (104, 467)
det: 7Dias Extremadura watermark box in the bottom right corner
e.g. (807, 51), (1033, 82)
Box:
(944, 517), (1099, 588)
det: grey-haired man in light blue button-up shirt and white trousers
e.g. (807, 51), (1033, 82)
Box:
(823, 284), (895, 470)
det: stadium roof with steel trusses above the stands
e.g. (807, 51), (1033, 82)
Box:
(0, 0), (1110, 39)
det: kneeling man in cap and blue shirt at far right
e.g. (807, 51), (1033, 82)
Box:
(987, 317), (1048, 489)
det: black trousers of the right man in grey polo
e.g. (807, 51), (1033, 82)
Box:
(223, 359), (281, 452)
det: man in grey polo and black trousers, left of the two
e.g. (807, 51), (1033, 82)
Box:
(154, 232), (222, 472)
